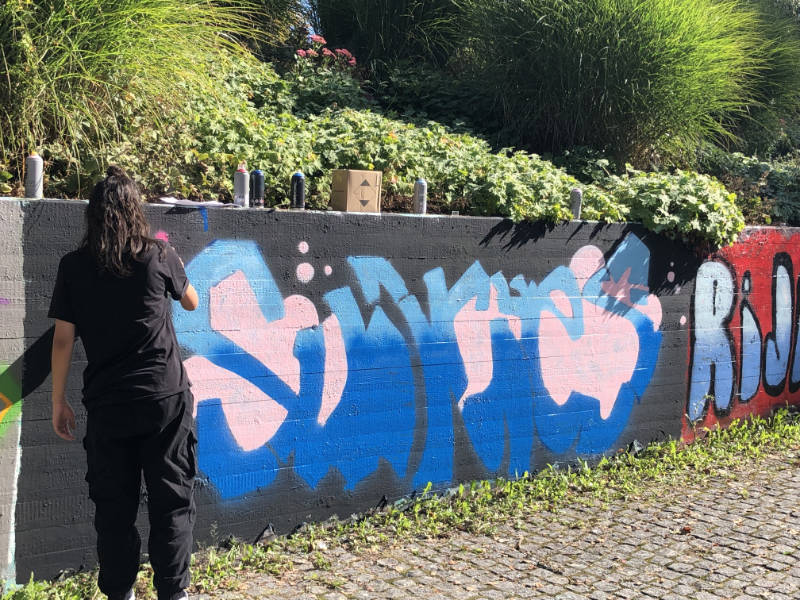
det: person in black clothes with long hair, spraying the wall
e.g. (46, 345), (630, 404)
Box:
(49, 167), (198, 600)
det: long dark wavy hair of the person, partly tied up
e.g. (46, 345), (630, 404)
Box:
(81, 166), (156, 277)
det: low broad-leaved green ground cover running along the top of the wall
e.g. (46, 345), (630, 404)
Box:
(28, 52), (741, 244)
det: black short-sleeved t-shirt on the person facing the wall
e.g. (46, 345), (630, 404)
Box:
(48, 242), (189, 408)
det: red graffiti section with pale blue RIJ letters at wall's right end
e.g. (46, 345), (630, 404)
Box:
(682, 229), (800, 441)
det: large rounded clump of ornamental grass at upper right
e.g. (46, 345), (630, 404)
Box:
(450, 0), (800, 164)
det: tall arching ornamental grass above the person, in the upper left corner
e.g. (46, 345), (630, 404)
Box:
(0, 0), (286, 185)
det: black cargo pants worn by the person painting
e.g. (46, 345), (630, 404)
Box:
(83, 390), (197, 600)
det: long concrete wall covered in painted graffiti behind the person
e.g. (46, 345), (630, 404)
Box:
(0, 200), (800, 580)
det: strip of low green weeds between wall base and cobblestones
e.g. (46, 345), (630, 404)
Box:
(2, 409), (800, 600)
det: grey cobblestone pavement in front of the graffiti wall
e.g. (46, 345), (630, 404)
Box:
(194, 452), (800, 600)
